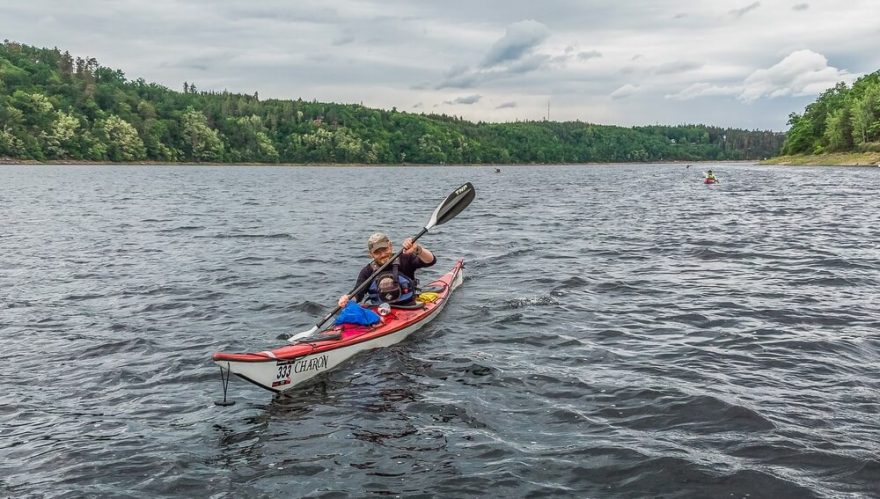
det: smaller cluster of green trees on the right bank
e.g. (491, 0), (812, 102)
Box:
(782, 71), (880, 154)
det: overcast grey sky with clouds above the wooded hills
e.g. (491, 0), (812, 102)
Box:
(0, 0), (880, 131)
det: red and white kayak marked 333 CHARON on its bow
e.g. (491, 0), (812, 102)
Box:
(213, 260), (464, 394)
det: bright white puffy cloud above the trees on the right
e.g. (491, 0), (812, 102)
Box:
(666, 50), (855, 103)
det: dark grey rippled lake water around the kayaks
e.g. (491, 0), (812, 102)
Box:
(0, 164), (880, 498)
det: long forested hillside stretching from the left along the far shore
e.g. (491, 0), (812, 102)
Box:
(0, 40), (784, 164)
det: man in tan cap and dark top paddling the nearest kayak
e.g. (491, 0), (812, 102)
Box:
(339, 232), (437, 307)
